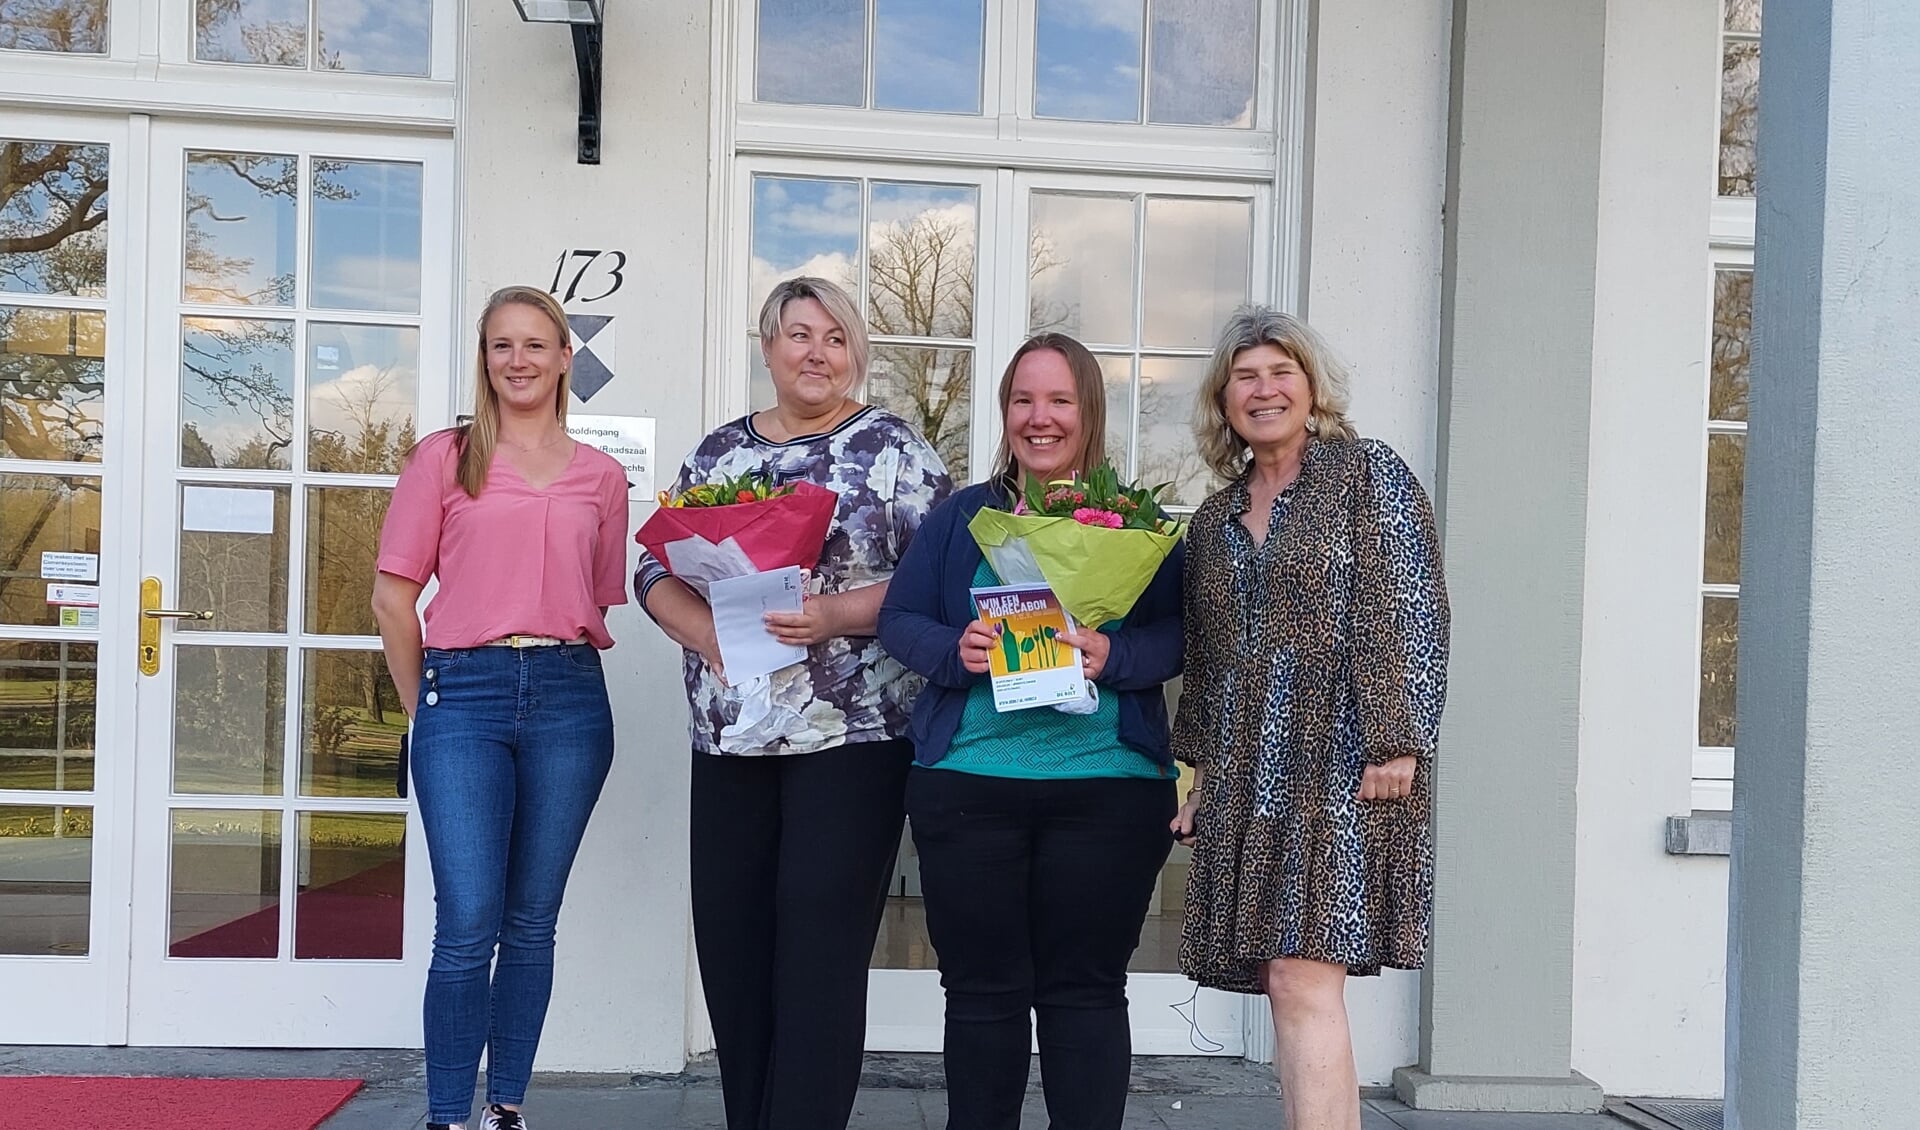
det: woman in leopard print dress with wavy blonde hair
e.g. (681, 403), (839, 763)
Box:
(1173, 307), (1448, 1130)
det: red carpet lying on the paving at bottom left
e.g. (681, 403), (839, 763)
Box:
(0, 1074), (361, 1130)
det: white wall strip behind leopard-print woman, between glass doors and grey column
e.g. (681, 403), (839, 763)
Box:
(1297, 0), (1450, 1086)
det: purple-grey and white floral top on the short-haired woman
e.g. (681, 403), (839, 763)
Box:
(634, 405), (952, 754)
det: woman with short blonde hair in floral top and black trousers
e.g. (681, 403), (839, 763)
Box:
(634, 278), (952, 1130)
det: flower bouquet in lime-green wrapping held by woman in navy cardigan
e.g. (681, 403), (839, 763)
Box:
(968, 462), (1187, 627)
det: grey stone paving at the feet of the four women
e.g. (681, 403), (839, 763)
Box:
(0, 1048), (1630, 1130)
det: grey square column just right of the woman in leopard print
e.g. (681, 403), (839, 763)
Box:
(1394, 0), (1607, 1111)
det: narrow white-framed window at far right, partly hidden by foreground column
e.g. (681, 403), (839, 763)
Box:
(1693, 0), (1761, 810)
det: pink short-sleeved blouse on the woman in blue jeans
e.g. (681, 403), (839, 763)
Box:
(378, 430), (628, 648)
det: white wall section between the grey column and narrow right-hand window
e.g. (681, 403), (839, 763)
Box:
(1572, 0), (1726, 1095)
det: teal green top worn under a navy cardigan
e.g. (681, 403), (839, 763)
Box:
(931, 562), (1177, 781)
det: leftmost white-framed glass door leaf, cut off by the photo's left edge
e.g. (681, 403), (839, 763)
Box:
(0, 116), (125, 1044)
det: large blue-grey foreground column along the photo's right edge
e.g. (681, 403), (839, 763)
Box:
(1726, 0), (1920, 1130)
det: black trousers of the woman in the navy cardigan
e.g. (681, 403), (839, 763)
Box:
(906, 767), (1175, 1130)
